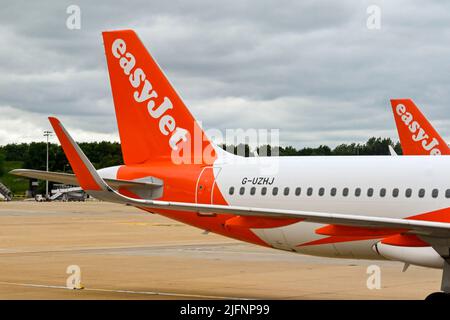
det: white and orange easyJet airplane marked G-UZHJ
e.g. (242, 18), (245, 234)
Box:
(12, 30), (450, 297)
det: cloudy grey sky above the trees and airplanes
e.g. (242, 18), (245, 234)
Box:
(0, 0), (450, 147)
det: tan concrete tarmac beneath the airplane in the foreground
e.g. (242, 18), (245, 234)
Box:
(0, 201), (441, 299)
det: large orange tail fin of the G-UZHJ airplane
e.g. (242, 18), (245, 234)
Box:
(103, 30), (215, 165)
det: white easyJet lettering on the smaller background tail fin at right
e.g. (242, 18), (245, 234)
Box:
(395, 104), (441, 156)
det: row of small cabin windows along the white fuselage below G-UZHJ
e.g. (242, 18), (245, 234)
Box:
(228, 187), (450, 198)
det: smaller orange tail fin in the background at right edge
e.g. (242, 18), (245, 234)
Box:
(391, 99), (450, 155)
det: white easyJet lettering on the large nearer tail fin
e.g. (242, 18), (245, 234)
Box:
(111, 39), (188, 150)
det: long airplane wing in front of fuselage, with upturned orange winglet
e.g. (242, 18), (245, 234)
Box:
(44, 118), (450, 238)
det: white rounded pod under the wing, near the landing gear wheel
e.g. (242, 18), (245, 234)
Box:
(373, 242), (444, 269)
